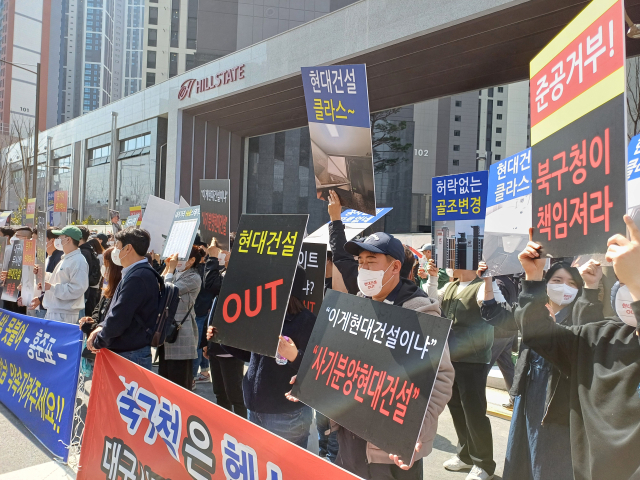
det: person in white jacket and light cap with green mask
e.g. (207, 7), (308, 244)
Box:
(38, 225), (89, 323)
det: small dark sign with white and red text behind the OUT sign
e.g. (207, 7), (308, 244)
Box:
(200, 179), (230, 250)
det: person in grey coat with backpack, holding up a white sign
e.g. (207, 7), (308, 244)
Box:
(158, 246), (202, 390)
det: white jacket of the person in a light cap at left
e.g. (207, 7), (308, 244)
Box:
(42, 249), (93, 316)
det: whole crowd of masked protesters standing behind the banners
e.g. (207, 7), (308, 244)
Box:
(0, 192), (640, 480)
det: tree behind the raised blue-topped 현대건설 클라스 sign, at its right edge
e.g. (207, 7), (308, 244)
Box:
(371, 108), (413, 173)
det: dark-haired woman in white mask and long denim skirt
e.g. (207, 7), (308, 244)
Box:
(503, 260), (603, 480)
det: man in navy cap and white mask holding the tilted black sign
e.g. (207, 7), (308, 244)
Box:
(336, 233), (454, 480)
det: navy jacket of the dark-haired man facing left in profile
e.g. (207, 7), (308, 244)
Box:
(95, 262), (159, 352)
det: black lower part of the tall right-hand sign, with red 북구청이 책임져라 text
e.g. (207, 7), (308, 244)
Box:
(531, 95), (626, 258)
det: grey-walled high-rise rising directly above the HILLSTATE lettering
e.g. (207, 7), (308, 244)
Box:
(143, 0), (356, 87)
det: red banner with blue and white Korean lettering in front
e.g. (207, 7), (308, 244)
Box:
(78, 350), (358, 480)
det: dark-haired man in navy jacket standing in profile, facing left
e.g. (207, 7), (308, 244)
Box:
(87, 227), (159, 370)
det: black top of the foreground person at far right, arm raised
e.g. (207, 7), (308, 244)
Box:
(515, 281), (640, 480)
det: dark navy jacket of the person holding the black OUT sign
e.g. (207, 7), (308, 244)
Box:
(224, 308), (316, 413)
